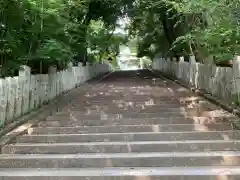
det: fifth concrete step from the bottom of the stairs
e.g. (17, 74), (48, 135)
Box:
(28, 123), (233, 134)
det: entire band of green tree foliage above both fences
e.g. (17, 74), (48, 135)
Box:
(0, 0), (240, 76)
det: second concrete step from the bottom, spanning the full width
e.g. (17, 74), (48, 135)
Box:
(0, 152), (240, 168)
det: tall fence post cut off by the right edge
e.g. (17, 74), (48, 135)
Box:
(232, 56), (240, 102)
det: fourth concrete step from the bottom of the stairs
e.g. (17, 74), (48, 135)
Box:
(17, 131), (240, 143)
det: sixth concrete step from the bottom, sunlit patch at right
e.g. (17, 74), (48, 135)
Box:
(38, 117), (231, 127)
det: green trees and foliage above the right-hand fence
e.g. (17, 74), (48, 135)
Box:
(130, 0), (240, 62)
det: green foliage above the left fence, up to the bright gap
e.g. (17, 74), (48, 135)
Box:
(0, 0), (132, 76)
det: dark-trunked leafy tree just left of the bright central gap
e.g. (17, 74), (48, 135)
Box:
(68, 0), (133, 62)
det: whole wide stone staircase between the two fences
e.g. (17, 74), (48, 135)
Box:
(0, 70), (240, 180)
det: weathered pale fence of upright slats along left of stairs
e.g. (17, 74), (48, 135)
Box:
(0, 63), (110, 127)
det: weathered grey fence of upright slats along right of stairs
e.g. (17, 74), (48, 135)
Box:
(152, 56), (240, 103)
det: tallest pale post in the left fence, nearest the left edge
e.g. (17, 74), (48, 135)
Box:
(19, 65), (31, 114)
